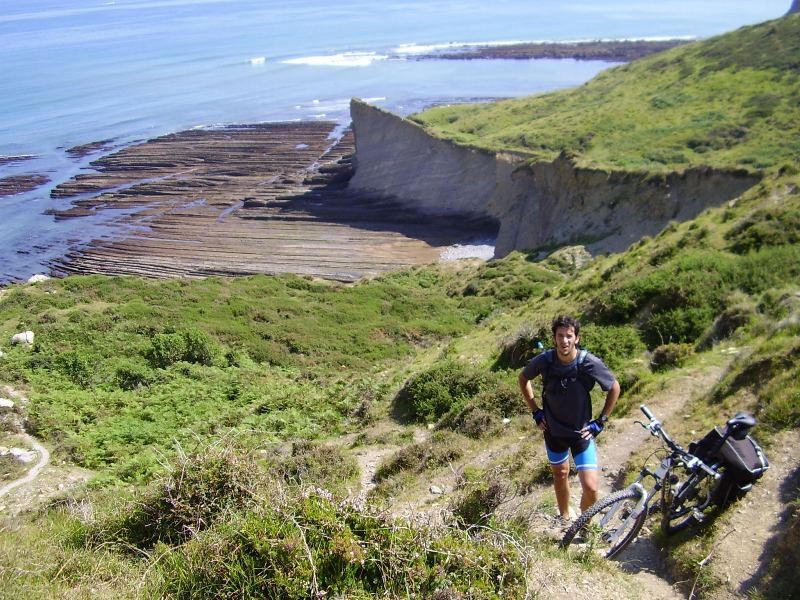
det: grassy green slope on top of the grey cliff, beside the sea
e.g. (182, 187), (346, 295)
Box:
(414, 15), (800, 171)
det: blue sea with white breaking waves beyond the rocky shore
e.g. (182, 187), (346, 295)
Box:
(0, 0), (790, 285)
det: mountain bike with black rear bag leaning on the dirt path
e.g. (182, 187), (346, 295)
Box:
(560, 404), (769, 558)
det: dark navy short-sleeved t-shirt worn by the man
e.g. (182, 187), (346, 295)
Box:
(522, 349), (616, 439)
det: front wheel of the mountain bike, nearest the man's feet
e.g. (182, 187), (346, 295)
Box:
(561, 487), (647, 558)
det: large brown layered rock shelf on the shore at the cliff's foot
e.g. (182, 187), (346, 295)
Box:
(51, 122), (494, 281)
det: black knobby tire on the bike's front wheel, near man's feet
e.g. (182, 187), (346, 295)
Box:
(561, 487), (648, 558)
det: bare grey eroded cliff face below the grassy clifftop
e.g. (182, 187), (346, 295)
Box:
(349, 100), (757, 257)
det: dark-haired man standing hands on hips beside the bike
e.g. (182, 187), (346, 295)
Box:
(519, 316), (619, 521)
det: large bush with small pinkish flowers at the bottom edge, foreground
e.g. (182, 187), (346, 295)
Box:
(150, 492), (525, 600)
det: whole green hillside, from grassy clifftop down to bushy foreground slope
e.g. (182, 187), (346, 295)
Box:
(0, 10), (800, 600)
